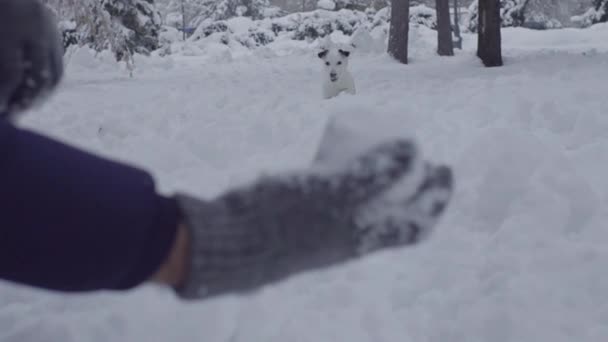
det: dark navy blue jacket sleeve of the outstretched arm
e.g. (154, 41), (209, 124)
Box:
(0, 120), (179, 291)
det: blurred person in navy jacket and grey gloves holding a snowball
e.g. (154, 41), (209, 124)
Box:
(0, 0), (453, 300)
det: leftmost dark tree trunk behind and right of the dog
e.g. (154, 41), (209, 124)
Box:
(388, 0), (410, 64)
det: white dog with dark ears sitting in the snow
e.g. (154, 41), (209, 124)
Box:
(318, 48), (356, 99)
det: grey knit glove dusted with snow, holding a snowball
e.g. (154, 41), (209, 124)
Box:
(177, 141), (452, 299)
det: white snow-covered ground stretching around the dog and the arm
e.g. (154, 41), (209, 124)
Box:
(0, 25), (608, 342)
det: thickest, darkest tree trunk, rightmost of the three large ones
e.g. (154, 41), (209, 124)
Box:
(477, 0), (503, 67)
